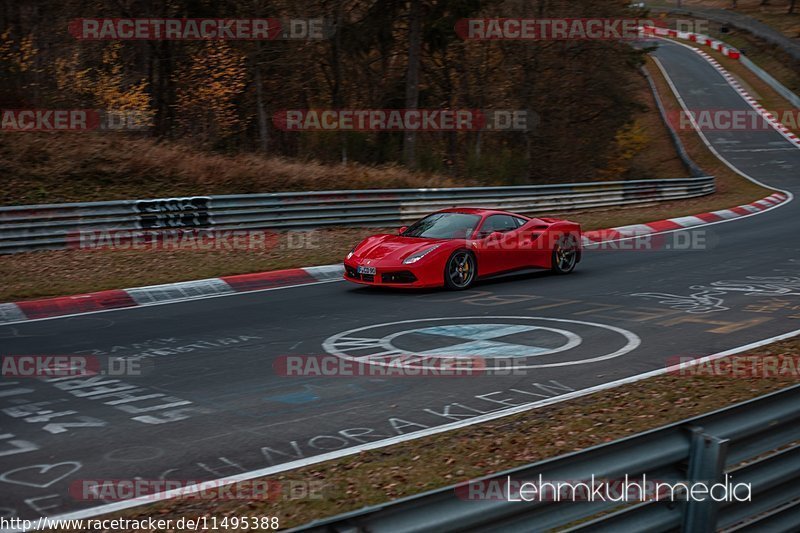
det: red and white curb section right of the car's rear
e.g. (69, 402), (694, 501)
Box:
(583, 192), (789, 246)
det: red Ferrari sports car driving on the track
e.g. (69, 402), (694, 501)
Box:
(344, 207), (581, 290)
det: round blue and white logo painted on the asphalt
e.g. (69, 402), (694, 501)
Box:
(322, 316), (641, 369)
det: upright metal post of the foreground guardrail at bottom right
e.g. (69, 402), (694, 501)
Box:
(683, 427), (729, 533)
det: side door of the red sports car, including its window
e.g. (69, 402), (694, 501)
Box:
(475, 215), (524, 275)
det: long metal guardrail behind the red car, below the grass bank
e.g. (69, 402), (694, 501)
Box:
(0, 176), (715, 253)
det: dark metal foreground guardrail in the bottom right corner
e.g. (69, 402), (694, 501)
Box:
(292, 385), (800, 533)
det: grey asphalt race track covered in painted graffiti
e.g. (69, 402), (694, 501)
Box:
(0, 42), (800, 517)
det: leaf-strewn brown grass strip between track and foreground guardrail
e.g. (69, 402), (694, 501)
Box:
(54, 337), (800, 528)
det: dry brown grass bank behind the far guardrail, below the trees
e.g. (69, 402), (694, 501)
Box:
(0, 73), (685, 205)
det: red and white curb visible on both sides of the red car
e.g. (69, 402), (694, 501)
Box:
(0, 193), (788, 324)
